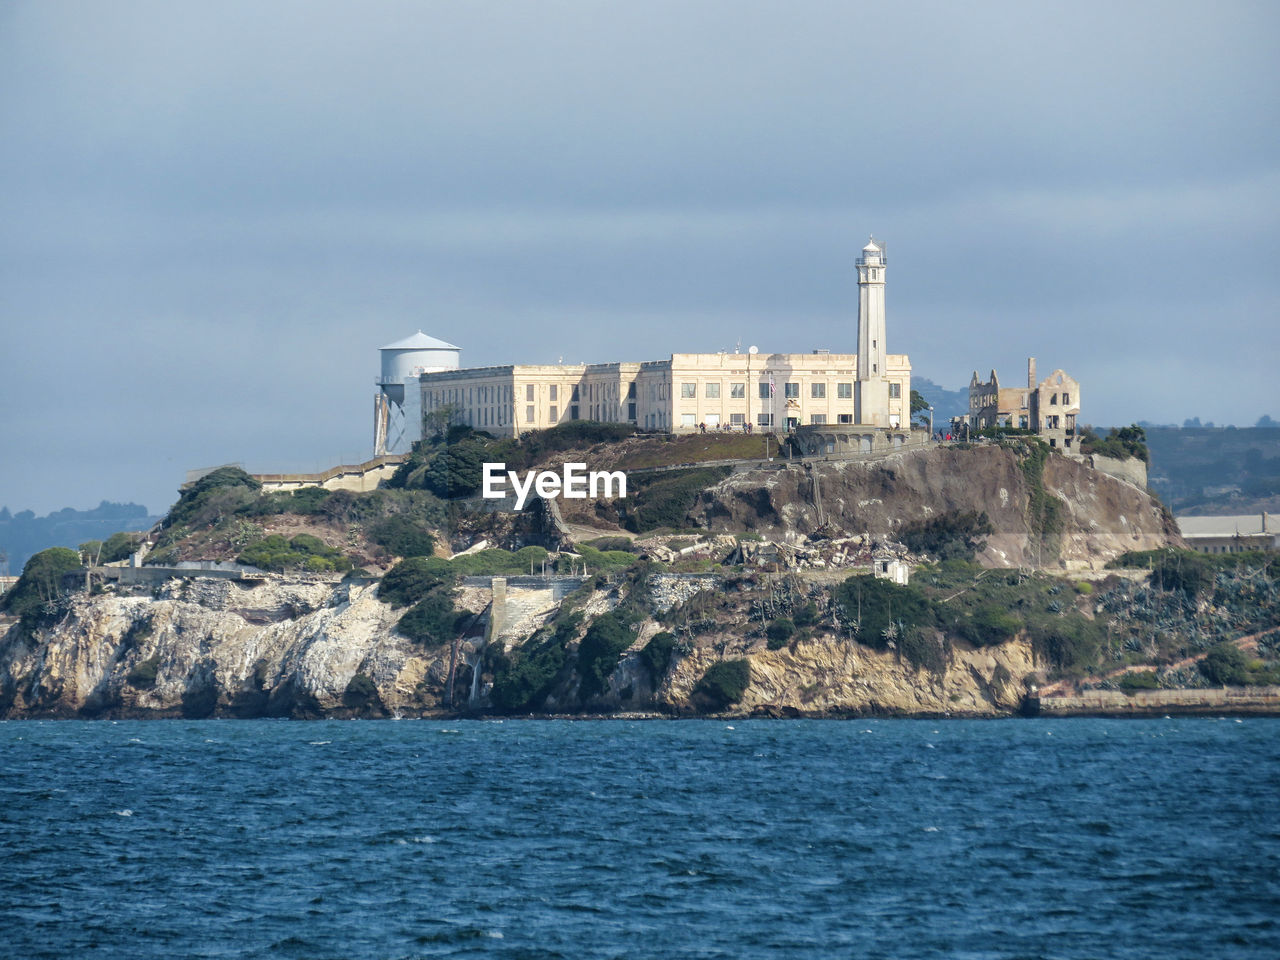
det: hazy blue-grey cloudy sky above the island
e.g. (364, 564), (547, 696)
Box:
(0, 0), (1280, 513)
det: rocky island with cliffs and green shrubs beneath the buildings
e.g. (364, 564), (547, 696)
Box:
(0, 422), (1280, 718)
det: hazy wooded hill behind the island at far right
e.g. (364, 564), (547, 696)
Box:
(1147, 426), (1280, 513)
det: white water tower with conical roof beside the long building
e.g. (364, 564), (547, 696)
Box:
(374, 330), (462, 457)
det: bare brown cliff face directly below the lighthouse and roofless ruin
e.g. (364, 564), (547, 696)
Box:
(694, 445), (1180, 568)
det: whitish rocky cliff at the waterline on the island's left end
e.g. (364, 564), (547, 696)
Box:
(0, 579), (447, 717)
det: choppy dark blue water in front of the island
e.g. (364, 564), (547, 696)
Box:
(0, 718), (1280, 960)
